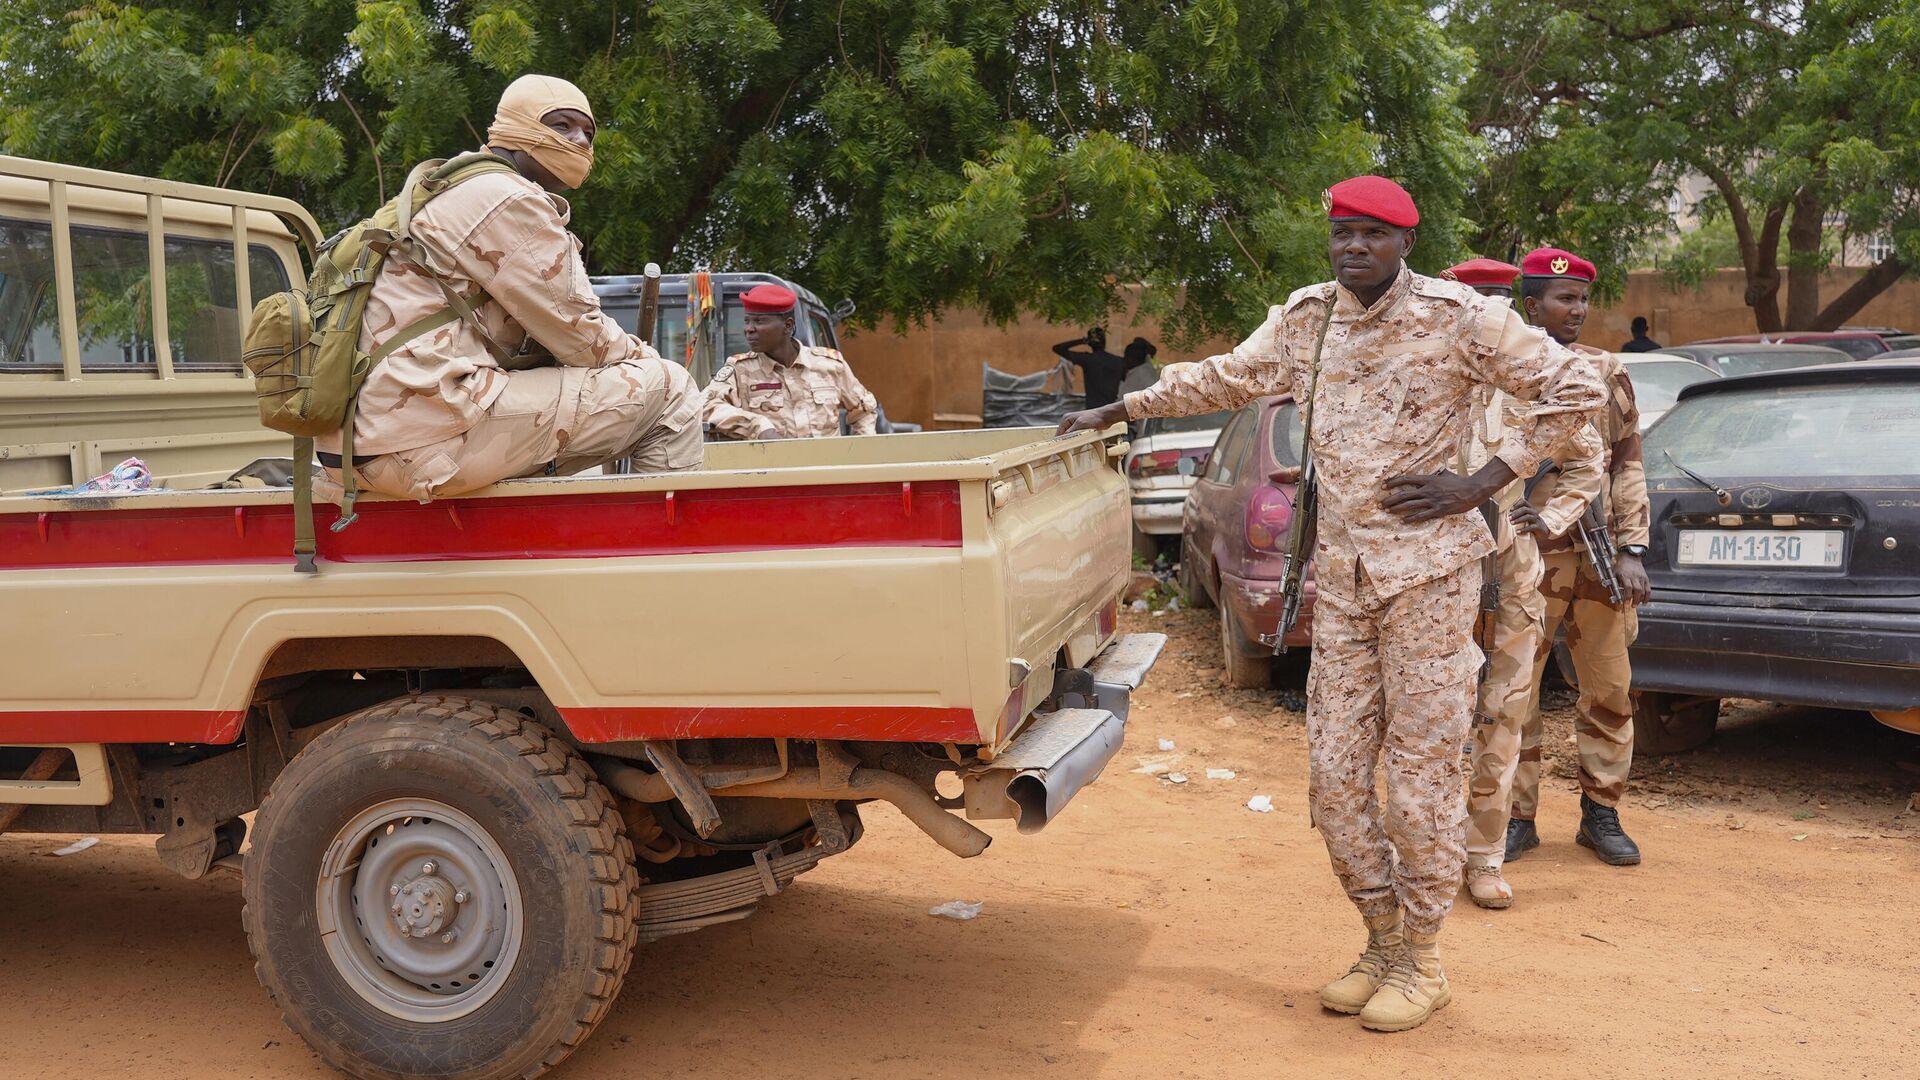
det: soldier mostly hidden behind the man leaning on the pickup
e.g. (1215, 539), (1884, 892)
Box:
(1440, 259), (1603, 907)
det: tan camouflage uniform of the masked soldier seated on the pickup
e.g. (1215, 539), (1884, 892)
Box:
(317, 161), (701, 502)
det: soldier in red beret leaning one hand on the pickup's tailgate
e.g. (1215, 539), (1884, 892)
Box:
(1060, 177), (1605, 1032)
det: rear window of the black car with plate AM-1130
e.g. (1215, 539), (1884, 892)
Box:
(1645, 380), (1920, 482)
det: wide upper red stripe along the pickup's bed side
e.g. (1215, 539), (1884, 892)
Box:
(0, 480), (960, 571)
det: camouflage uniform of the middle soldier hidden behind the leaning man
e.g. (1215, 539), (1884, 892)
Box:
(1465, 386), (1605, 867)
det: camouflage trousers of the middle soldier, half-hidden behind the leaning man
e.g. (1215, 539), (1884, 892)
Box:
(1467, 534), (1546, 867)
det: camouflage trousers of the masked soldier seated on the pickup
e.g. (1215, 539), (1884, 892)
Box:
(343, 357), (705, 502)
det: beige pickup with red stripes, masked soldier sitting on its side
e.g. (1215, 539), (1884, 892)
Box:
(0, 427), (1164, 1078)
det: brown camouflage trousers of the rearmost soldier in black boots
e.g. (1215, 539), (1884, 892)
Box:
(1513, 552), (1640, 821)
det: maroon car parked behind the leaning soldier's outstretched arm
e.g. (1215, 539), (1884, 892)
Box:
(1181, 396), (1313, 686)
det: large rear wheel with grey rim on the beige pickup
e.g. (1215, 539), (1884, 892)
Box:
(242, 694), (639, 1080)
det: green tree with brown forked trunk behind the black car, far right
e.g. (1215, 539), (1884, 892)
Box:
(1450, 0), (1920, 331)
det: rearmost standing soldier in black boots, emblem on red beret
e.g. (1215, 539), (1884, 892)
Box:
(1505, 248), (1651, 867)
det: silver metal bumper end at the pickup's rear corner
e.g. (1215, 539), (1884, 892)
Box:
(962, 709), (1127, 832)
